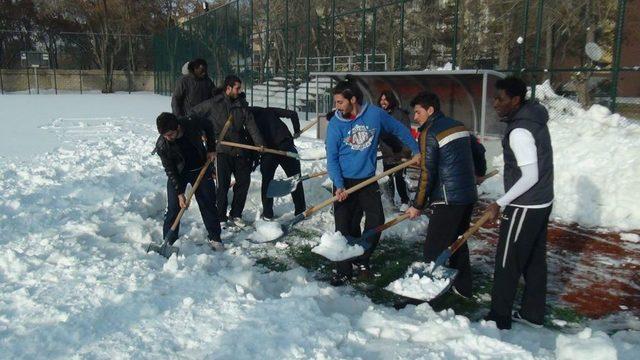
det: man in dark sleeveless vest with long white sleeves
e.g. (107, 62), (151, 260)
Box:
(486, 77), (553, 329)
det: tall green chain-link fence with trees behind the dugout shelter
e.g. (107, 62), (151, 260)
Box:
(153, 0), (640, 118)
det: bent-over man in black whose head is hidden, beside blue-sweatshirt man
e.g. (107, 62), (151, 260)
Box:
(249, 106), (306, 220)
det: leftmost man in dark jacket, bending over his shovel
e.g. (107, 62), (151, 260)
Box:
(155, 113), (224, 250)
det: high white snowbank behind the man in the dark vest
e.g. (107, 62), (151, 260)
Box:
(480, 82), (640, 230)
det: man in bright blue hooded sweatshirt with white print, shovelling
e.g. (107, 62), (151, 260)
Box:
(325, 81), (420, 286)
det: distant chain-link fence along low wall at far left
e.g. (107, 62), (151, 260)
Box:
(0, 30), (154, 94)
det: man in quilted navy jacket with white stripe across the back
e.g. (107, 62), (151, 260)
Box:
(407, 91), (478, 298)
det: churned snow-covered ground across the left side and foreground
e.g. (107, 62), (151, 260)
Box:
(0, 94), (640, 359)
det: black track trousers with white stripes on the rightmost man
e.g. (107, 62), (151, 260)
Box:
(491, 206), (551, 324)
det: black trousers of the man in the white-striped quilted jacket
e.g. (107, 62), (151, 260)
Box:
(424, 204), (473, 297)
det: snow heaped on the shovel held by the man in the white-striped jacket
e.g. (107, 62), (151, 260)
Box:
(385, 262), (451, 301)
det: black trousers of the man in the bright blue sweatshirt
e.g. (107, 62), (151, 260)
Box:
(333, 179), (384, 276)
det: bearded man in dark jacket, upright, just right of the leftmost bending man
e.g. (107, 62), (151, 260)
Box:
(191, 75), (264, 228)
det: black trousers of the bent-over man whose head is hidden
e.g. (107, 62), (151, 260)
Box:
(260, 147), (307, 218)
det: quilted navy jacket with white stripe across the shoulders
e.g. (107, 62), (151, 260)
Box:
(413, 112), (478, 209)
